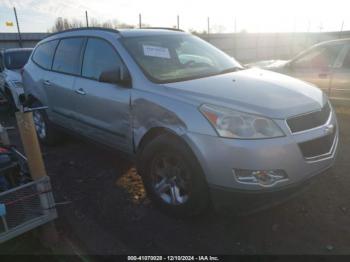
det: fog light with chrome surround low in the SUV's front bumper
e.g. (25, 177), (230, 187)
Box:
(233, 169), (288, 186)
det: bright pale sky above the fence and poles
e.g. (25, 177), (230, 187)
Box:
(0, 0), (350, 32)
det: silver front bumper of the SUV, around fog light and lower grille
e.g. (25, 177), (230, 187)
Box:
(186, 107), (339, 207)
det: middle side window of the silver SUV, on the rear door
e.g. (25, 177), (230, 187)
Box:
(52, 37), (85, 75)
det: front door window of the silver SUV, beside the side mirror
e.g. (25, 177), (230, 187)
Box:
(82, 38), (122, 80)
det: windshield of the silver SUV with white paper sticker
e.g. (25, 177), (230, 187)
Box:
(122, 35), (242, 83)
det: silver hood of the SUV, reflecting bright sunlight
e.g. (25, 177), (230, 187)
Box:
(164, 68), (327, 119)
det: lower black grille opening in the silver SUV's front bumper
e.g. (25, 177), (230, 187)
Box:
(299, 128), (337, 158)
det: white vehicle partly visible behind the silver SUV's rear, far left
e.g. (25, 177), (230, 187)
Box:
(0, 48), (33, 109)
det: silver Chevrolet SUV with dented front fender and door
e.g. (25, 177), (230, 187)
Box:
(23, 28), (338, 215)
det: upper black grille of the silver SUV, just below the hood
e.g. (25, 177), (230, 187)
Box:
(287, 103), (331, 133)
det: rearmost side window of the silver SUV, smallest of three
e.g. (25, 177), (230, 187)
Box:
(33, 40), (58, 69)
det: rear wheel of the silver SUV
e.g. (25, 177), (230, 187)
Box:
(31, 101), (61, 145)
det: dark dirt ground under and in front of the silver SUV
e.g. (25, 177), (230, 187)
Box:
(0, 107), (350, 255)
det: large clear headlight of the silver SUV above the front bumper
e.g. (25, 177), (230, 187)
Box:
(200, 105), (284, 139)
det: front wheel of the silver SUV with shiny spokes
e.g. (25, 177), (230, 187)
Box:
(138, 134), (209, 217)
